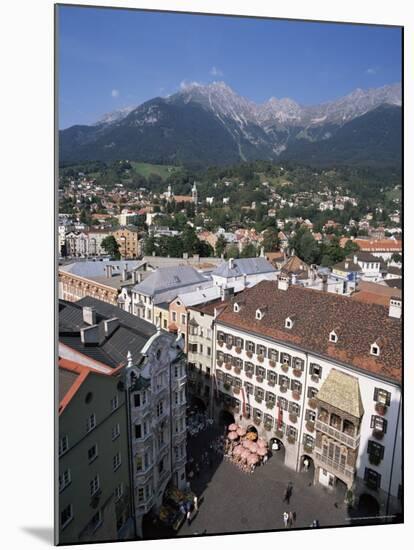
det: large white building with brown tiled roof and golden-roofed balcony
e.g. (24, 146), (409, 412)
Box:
(213, 280), (402, 515)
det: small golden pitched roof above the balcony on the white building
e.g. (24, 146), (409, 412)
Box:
(318, 369), (364, 418)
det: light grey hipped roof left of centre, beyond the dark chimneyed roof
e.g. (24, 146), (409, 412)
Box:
(133, 265), (207, 301)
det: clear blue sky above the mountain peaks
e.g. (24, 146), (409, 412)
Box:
(58, 6), (401, 128)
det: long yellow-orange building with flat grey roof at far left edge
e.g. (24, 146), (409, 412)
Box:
(58, 260), (139, 305)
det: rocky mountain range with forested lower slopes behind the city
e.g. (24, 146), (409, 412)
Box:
(59, 82), (402, 166)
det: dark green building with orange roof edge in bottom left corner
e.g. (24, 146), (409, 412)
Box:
(58, 358), (135, 544)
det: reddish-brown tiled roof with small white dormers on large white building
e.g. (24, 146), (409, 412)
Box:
(219, 281), (402, 382)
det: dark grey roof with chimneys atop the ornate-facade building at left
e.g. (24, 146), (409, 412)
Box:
(59, 296), (157, 368)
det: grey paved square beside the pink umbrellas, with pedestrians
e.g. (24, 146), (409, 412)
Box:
(178, 429), (349, 536)
